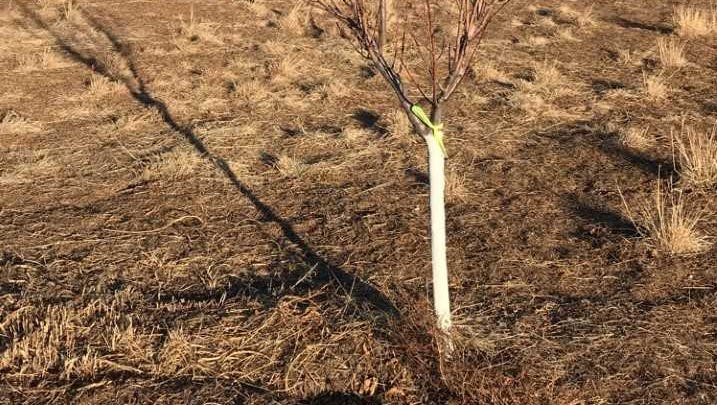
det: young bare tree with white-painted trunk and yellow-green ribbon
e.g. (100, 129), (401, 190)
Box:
(313, 0), (510, 341)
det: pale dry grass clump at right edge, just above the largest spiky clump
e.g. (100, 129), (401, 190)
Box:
(671, 124), (717, 188)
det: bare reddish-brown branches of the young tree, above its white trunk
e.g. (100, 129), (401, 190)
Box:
(312, 0), (510, 130)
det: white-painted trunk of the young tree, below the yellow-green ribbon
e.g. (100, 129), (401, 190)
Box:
(426, 135), (452, 334)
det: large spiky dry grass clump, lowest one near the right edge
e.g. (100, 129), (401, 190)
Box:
(623, 181), (709, 255)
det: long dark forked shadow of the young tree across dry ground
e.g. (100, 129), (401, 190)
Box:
(18, 3), (399, 317)
